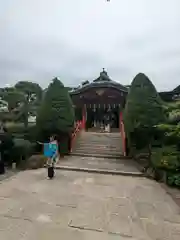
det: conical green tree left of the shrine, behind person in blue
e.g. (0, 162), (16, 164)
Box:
(37, 78), (75, 139)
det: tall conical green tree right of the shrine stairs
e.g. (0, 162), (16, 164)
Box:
(124, 73), (165, 147)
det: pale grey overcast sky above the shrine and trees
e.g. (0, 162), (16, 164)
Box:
(0, 0), (180, 91)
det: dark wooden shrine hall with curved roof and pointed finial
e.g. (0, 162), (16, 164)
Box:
(70, 69), (128, 131)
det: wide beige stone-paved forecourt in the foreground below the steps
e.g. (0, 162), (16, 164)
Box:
(0, 169), (180, 240)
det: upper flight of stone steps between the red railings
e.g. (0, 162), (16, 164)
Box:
(72, 132), (123, 158)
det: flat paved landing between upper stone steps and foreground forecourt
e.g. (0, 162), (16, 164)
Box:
(58, 156), (140, 174)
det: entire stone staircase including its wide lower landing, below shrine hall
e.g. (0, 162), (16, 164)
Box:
(56, 129), (143, 177)
